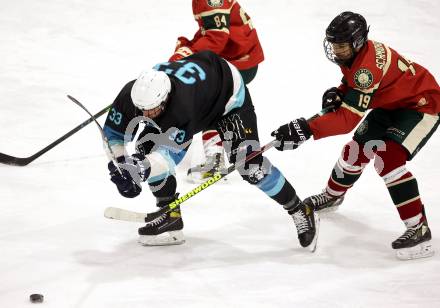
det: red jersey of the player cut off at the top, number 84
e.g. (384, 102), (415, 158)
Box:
(183, 0), (264, 70)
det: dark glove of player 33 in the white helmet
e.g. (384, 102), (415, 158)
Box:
(108, 154), (151, 198)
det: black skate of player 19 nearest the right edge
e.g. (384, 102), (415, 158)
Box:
(391, 222), (434, 260)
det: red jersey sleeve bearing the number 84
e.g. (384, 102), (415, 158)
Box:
(191, 0), (235, 54)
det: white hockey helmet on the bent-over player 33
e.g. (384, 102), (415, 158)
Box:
(131, 69), (171, 110)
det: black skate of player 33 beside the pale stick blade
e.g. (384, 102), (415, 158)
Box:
(138, 195), (185, 246)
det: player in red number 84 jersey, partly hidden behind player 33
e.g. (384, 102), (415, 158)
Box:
(170, 0), (264, 178)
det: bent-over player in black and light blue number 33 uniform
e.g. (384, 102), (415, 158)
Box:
(104, 51), (319, 251)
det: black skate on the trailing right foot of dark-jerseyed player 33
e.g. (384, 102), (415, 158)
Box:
(287, 202), (319, 252)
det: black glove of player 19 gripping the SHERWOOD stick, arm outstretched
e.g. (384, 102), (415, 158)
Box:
(271, 118), (312, 151)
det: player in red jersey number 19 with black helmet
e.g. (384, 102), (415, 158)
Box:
(272, 12), (440, 259)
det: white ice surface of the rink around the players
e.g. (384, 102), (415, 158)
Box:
(0, 0), (440, 308)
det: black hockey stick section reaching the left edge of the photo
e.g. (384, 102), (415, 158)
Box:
(0, 105), (111, 167)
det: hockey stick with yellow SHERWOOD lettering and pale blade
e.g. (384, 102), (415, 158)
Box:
(104, 140), (277, 223)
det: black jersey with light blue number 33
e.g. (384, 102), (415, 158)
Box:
(104, 51), (245, 170)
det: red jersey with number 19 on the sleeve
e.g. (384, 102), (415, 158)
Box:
(309, 40), (440, 139)
